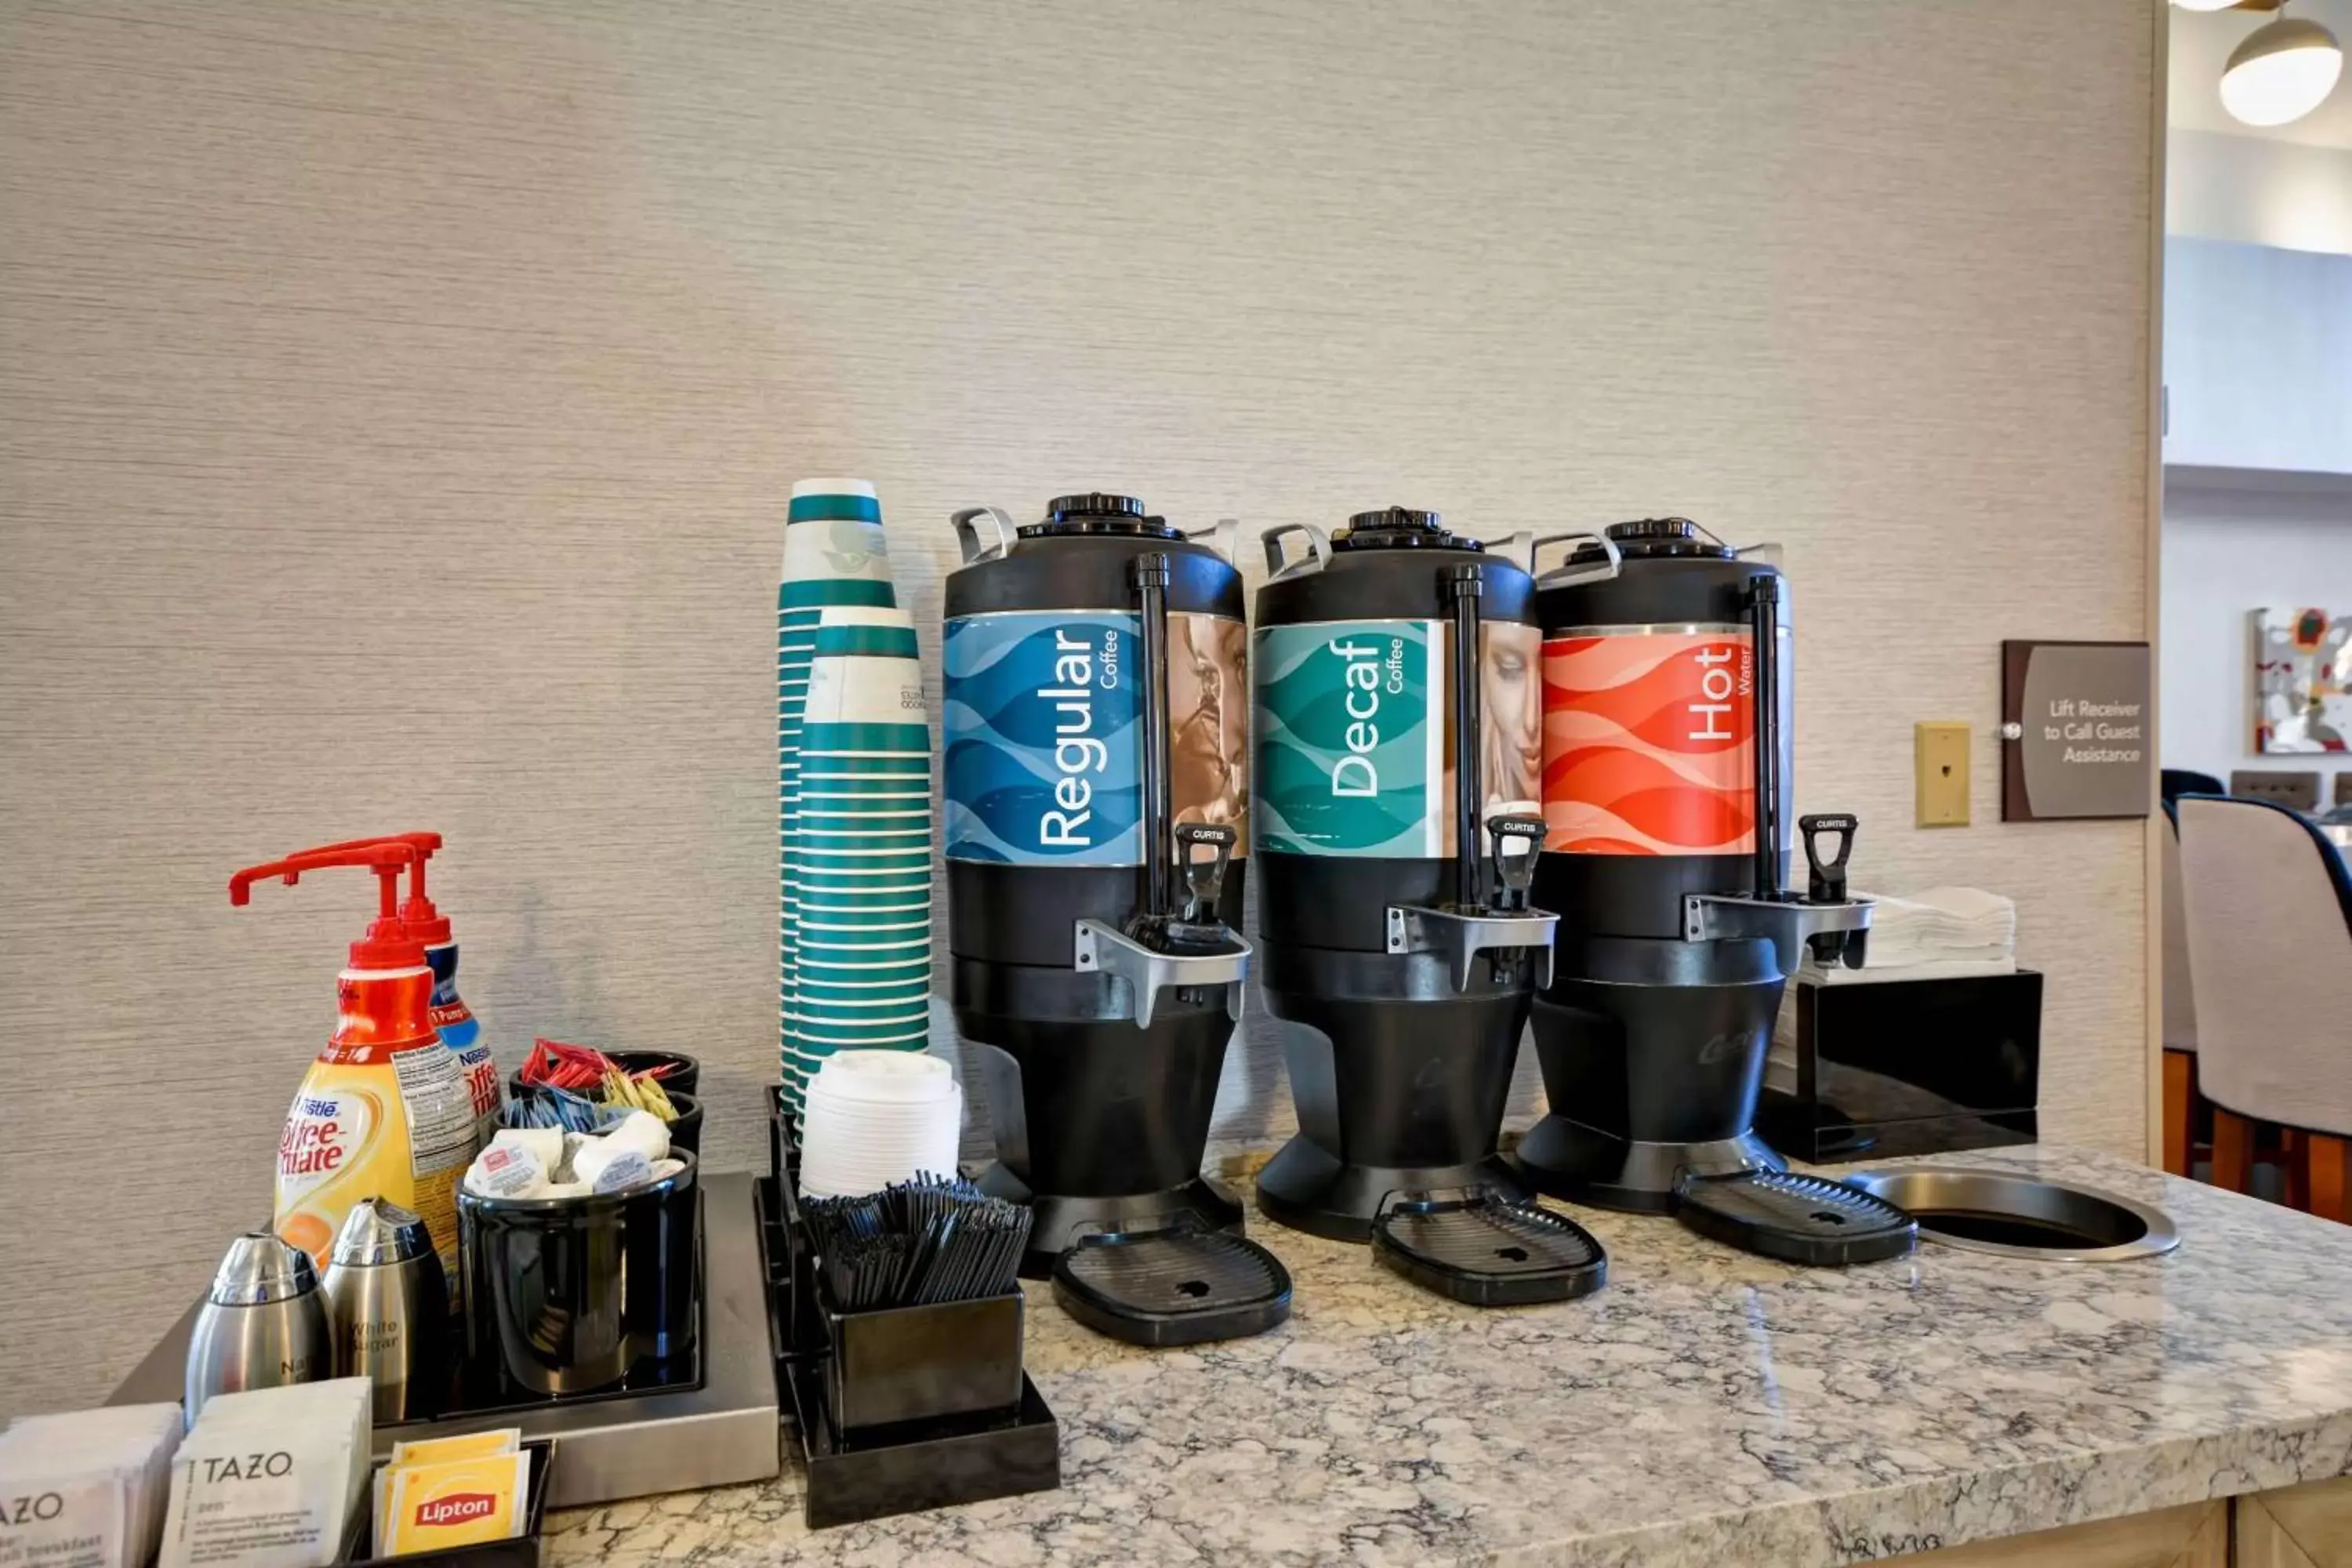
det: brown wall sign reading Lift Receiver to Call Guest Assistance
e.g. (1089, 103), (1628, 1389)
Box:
(2002, 642), (2157, 822)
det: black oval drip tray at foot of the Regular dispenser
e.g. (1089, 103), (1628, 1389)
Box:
(1054, 1229), (1291, 1345)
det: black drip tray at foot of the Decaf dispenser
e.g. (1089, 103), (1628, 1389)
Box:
(1371, 1189), (1609, 1307)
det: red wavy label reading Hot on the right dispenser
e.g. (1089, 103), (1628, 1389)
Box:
(1543, 633), (1755, 855)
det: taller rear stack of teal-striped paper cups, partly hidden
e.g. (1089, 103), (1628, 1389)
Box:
(776, 480), (898, 1105)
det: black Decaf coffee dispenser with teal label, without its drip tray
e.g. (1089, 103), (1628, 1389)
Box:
(1254, 508), (1552, 1241)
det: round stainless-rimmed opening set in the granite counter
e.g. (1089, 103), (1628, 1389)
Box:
(1842, 1166), (2180, 1262)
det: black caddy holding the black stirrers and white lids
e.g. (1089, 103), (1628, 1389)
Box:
(757, 1095), (1061, 1530)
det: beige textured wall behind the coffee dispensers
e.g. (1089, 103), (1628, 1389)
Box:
(0, 0), (2150, 1413)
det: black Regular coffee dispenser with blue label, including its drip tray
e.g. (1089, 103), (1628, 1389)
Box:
(941, 494), (1289, 1342)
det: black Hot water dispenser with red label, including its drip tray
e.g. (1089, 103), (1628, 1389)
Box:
(1517, 517), (1910, 1262)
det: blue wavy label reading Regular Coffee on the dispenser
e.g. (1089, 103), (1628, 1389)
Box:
(941, 609), (1143, 865)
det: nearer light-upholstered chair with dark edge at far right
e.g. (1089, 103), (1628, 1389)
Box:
(2173, 794), (2352, 1222)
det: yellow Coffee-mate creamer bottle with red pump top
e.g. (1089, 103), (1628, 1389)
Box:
(228, 841), (480, 1298)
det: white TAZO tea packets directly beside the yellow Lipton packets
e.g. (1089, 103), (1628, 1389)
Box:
(160, 1377), (374, 1568)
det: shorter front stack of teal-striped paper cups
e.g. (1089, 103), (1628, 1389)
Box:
(783, 609), (931, 1109)
